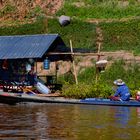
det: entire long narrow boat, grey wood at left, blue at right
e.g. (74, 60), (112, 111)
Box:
(0, 93), (140, 107)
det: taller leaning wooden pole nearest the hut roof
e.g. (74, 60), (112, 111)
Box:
(70, 40), (78, 84)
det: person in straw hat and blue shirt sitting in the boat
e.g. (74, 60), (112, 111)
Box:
(110, 79), (131, 101)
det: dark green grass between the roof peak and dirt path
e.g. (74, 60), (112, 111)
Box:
(48, 19), (96, 50)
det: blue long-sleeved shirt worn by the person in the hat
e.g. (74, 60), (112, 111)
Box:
(114, 84), (131, 101)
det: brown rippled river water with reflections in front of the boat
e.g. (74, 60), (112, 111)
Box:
(0, 104), (140, 140)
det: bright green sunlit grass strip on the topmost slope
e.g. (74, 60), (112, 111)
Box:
(57, 0), (140, 19)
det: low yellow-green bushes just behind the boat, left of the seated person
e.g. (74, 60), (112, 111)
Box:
(62, 83), (112, 99)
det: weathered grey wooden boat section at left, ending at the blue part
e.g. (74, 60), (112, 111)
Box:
(0, 93), (80, 105)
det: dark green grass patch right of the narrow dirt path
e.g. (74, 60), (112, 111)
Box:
(100, 19), (140, 54)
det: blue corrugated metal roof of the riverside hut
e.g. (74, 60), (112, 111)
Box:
(0, 34), (63, 59)
